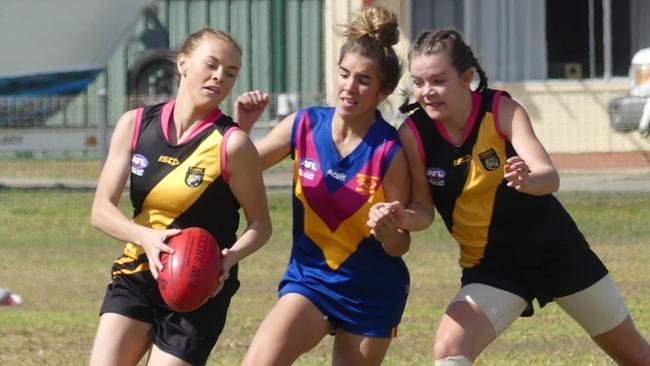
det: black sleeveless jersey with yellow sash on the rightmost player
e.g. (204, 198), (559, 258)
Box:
(405, 89), (587, 268)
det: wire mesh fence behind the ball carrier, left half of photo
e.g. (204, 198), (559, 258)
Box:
(0, 93), (324, 159)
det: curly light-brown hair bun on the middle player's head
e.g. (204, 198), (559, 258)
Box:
(339, 6), (399, 47)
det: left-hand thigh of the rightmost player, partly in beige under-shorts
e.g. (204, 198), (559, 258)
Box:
(434, 283), (527, 359)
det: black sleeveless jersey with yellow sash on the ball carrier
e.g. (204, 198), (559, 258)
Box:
(113, 103), (239, 275)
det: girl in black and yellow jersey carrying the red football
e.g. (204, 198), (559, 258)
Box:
(90, 28), (271, 366)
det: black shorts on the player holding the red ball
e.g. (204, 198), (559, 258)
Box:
(100, 266), (239, 365)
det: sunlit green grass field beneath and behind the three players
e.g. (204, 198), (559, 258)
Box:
(0, 190), (650, 366)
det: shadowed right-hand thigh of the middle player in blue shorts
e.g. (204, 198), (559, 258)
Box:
(332, 328), (392, 366)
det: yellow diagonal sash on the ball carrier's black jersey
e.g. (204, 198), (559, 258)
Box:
(124, 130), (223, 258)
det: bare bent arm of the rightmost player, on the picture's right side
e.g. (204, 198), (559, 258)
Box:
(499, 98), (560, 195)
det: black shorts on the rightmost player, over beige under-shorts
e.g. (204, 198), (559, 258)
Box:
(461, 243), (608, 316)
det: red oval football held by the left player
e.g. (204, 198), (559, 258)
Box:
(158, 227), (221, 312)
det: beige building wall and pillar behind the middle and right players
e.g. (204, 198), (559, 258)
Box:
(325, 0), (650, 153)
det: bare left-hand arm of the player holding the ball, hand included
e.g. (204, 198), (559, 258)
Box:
(90, 111), (179, 278)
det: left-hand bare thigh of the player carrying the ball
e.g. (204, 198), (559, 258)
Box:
(90, 313), (151, 366)
